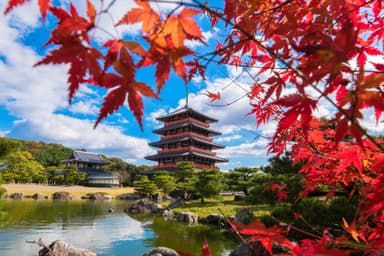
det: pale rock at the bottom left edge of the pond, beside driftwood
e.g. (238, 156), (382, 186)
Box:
(39, 240), (96, 256)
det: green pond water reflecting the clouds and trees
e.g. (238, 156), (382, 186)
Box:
(0, 200), (237, 256)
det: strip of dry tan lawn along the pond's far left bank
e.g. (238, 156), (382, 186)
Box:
(1, 184), (134, 199)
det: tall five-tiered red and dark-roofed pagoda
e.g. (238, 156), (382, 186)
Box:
(145, 106), (228, 172)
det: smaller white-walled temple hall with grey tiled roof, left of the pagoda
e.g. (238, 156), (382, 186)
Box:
(63, 150), (120, 187)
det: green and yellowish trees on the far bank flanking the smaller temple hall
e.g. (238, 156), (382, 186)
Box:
(0, 138), (149, 185)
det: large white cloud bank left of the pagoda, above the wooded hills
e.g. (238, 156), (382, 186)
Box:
(0, 4), (153, 162)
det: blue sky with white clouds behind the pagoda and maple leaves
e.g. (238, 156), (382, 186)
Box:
(0, 0), (382, 170)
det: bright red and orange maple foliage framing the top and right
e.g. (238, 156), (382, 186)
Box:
(4, 0), (384, 255)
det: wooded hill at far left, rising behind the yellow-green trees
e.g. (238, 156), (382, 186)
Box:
(0, 138), (72, 167)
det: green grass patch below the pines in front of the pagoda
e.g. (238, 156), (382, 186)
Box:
(174, 196), (273, 217)
